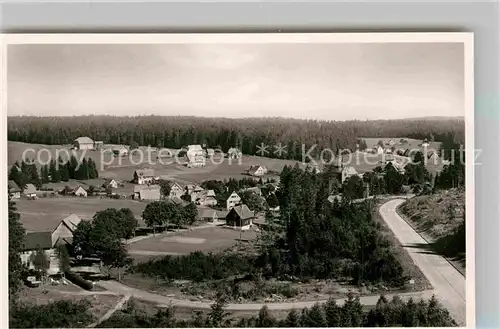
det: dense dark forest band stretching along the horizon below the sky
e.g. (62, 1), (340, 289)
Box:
(8, 116), (465, 159)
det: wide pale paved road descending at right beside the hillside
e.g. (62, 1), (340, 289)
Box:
(379, 199), (466, 325)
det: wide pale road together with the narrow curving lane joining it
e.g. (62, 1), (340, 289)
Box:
(98, 199), (465, 325)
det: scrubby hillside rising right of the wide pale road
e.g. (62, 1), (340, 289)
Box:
(399, 188), (466, 273)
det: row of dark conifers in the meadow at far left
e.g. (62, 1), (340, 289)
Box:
(9, 156), (99, 188)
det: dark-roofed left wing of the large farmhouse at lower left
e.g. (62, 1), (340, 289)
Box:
(21, 232), (59, 275)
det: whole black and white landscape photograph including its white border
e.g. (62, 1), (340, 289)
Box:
(2, 33), (472, 328)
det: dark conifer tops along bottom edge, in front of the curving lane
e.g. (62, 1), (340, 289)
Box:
(99, 293), (457, 328)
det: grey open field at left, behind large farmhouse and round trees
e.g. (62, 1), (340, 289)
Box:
(15, 197), (147, 232)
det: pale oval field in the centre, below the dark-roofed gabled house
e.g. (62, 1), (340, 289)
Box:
(129, 227), (257, 261)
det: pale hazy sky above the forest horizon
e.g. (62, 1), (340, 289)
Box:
(7, 43), (465, 120)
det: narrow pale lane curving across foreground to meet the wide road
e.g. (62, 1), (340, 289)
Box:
(98, 281), (433, 311)
